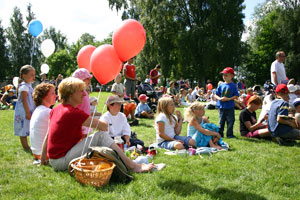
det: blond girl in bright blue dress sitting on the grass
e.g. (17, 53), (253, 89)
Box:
(184, 102), (222, 150)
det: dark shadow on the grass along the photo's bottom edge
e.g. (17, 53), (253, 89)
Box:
(159, 180), (266, 200)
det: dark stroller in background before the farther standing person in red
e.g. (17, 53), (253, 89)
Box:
(138, 83), (159, 112)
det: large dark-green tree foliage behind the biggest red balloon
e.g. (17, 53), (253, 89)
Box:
(109, 0), (244, 85)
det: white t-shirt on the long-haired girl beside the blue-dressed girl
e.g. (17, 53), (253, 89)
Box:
(155, 113), (177, 144)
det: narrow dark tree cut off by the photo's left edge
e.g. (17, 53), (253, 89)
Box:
(0, 20), (10, 81)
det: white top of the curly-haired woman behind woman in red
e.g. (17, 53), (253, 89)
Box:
(30, 105), (51, 155)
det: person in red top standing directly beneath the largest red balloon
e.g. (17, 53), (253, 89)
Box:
(123, 58), (136, 99)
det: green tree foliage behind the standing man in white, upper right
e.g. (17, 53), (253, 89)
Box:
(245, 0), (300, 84)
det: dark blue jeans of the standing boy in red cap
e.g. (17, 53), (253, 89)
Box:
(219, 108), (235, 137)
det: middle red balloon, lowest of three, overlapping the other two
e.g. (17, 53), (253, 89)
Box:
(91, 44), (123, 85)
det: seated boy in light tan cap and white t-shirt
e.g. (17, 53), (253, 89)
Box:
(100, 95), (144, 147)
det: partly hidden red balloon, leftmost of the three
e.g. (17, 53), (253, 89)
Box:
(77, 45), (96, 72)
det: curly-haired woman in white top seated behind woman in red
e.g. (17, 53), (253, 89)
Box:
(30, 83), (56, 160)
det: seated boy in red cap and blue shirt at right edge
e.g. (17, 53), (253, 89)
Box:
(268, 84), (300, 145)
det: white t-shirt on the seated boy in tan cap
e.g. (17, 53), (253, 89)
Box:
(100, 112), (131, 137)
